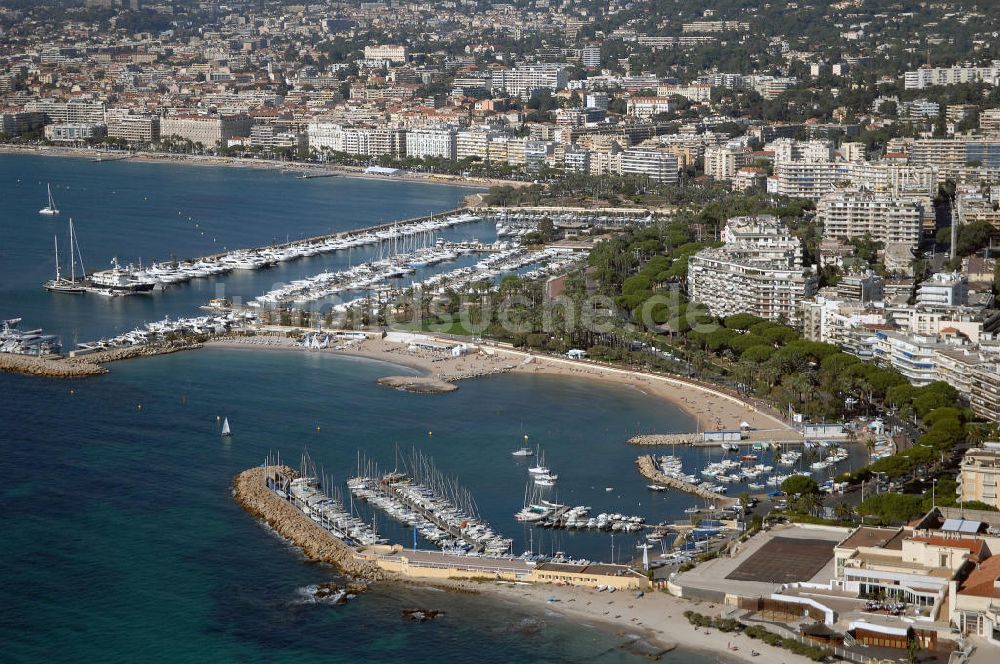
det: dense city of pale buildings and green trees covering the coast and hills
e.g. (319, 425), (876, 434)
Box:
(0, 0), (1000, 662)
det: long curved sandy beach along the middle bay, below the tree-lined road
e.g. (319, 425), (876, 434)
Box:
(209, 336), (791, 439)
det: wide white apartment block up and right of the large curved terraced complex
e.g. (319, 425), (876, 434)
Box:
(816, 191), (933, 247)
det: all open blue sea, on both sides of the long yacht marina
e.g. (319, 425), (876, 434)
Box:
(0, 155), (736, 664)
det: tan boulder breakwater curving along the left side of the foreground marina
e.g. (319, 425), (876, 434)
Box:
(233, 466), (384, 580)
